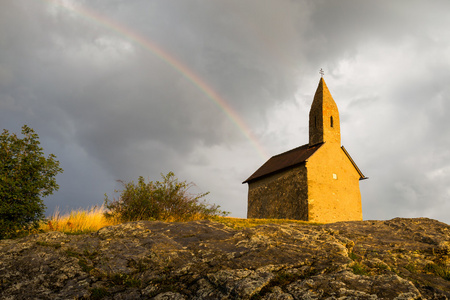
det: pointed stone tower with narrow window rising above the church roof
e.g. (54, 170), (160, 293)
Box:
(309, 77), (341, 146)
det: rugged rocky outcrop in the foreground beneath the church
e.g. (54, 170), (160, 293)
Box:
(0, 218), (450, 300)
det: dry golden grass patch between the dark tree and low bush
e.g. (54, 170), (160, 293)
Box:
(40, 206), (119, 234)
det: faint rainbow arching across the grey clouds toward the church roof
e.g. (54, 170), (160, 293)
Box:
(45, 0), (268, 160)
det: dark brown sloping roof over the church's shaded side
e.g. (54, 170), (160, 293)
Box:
(243, 143), (323, 183)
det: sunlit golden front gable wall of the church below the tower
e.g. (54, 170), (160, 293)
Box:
(306, 143), (362, 223)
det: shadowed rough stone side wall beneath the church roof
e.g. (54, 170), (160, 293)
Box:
(247, 164), (308, 221)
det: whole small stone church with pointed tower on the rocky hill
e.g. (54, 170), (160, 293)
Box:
(243, 78), (366, 223)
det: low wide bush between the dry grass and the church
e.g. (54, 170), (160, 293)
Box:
(105, 172), (228, 222)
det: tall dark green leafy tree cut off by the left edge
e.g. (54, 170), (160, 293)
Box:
(0, 125), (63, 239)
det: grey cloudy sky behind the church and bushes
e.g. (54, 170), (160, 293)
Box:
(0, 0), (450, 223)
